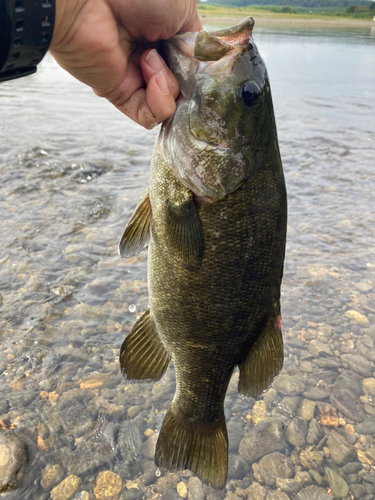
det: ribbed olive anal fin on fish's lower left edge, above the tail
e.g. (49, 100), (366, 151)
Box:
(120, 309), (171, 381)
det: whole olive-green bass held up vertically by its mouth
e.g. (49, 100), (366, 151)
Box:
(119, 17), (287, 489)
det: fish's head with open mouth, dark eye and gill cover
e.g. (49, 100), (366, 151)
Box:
(159, 17), (270, 201)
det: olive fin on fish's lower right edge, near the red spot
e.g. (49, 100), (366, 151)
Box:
(238, 307), (284, 398)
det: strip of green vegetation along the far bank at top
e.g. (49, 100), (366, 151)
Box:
(198, 0), (375, 19)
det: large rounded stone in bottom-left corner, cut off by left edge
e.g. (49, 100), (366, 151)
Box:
(0, 431), (29, 494)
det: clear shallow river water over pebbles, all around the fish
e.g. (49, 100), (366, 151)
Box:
(0, 21), (375, 500)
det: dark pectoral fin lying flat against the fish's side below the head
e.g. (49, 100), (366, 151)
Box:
(166, 193), (204, 271)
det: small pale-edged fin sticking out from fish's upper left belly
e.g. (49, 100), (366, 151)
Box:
(118, 189), (151, 259)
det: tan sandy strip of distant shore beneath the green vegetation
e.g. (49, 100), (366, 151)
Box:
(198, 6), (375, 28)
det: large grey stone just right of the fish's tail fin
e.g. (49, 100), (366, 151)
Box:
(239, 418), (287, 463)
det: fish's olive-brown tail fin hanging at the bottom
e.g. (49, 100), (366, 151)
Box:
(155, 402), (228, 490)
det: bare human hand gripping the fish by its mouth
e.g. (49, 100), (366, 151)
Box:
(50, 0), (202, 128)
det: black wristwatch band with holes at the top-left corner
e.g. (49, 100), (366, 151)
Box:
(0, 0), (55, 82)
